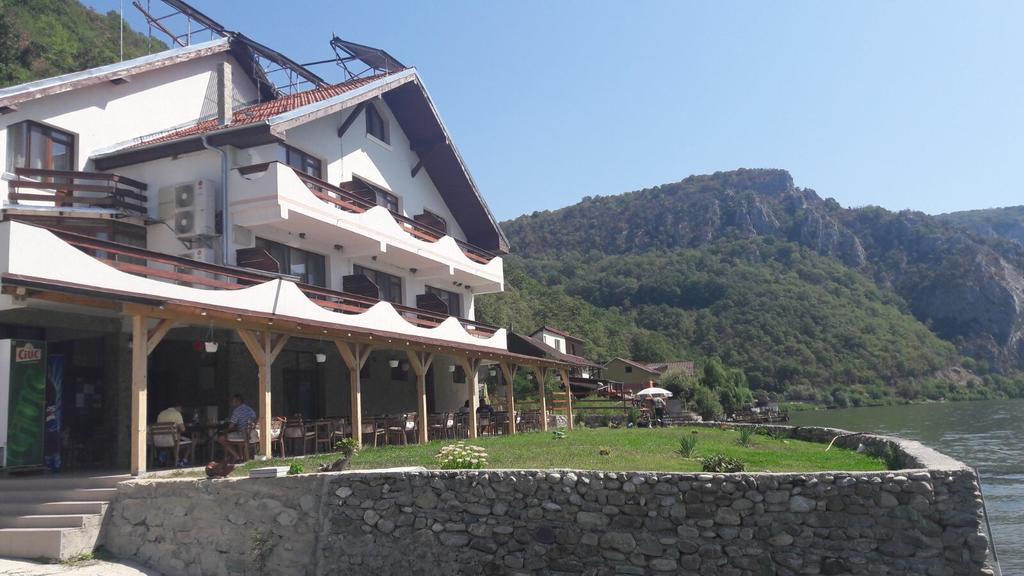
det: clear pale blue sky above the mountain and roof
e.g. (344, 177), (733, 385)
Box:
(86, 0), (1024, 219)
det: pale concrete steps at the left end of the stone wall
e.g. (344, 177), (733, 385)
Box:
(0, 475), (130, 560)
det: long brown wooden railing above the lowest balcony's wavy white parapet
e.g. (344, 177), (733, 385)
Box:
(48, 229), (498, 338)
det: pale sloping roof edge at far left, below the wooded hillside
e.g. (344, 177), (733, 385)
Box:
(0, 38), (230, 108)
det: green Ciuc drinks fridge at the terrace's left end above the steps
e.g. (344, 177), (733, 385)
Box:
(0, 339), (46, 467)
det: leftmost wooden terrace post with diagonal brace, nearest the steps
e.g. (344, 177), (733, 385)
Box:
(131, 314), (174, 476)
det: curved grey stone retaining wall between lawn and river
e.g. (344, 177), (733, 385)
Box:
(104, 428), (991, 576)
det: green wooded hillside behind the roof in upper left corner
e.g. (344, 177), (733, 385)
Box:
(0, 0), (167, 87)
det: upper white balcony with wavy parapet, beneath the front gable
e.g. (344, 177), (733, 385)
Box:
(228, 162), (504, 293)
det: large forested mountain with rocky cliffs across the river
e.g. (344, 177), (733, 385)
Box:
(479, 170), (1024, 401)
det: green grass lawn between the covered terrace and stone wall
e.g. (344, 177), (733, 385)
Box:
(232, 426), (886, 476)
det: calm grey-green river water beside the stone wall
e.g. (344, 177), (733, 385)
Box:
(791, 400), (1024, 575)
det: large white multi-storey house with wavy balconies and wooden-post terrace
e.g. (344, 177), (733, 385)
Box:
(0, 29), (571, 474)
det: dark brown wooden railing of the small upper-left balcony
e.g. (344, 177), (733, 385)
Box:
(7, 168), (147, 216)
